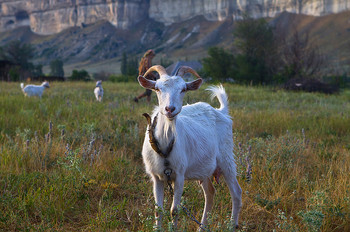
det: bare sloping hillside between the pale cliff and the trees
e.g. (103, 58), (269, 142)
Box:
(0, 11), (350, 74)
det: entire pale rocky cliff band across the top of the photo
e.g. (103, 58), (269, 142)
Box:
(0, 0), (350, 34)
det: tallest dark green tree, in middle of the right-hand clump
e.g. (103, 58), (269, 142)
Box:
(234, 15), (277, 84)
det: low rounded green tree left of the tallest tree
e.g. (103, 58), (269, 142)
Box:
(202, 47), (235, 81)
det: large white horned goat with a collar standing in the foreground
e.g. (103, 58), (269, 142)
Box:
(138, 65), (242, 230)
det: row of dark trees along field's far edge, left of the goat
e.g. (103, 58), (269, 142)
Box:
(0, 40), (143, 82)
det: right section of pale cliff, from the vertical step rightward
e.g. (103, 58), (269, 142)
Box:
(149, 0), (350, 25)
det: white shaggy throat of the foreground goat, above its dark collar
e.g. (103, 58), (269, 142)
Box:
(155, 113), (176, 142)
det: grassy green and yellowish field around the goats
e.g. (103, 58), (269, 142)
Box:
(0, 82), (350, 231)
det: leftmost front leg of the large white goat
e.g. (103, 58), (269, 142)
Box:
(152, 176), (164, 228)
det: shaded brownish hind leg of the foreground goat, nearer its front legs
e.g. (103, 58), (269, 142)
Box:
(200, 178), (215, 230)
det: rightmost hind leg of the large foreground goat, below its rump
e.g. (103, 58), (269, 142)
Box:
(222, 168), (242, 228)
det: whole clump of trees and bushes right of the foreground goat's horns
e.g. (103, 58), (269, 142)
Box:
(202, 16), (346, 89)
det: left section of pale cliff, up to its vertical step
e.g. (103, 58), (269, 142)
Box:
(0, 0), (149, 34)
